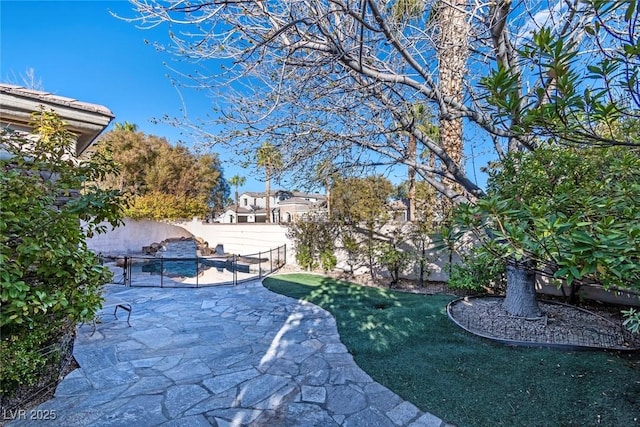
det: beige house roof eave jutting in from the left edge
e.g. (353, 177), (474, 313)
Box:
(0, 83), (115, 156)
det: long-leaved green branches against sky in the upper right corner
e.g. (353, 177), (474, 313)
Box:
(481, 0), (640, 148)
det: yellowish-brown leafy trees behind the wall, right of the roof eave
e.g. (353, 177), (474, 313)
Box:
(96, 129), (229, 219)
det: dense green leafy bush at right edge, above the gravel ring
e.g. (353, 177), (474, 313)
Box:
(456, 144), (640, 290)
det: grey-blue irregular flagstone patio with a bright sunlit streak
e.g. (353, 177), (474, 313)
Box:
(11, 281), (448, 427)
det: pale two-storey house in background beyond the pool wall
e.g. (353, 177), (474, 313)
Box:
(217, 190), (326, 224)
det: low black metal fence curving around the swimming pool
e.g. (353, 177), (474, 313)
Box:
(102, 245), (287, 288)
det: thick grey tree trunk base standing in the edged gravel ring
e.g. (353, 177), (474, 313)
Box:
(503, 263), (542, 317)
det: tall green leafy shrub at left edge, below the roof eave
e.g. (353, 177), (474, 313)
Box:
(0, 111), (121, 393)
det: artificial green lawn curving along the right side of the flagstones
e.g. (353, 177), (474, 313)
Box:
(264, 274), (640, 427)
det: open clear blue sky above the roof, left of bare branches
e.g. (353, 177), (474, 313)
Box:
(0, 0), (264, 191)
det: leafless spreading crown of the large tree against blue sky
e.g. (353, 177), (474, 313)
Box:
(122, 0), (624, 318)
